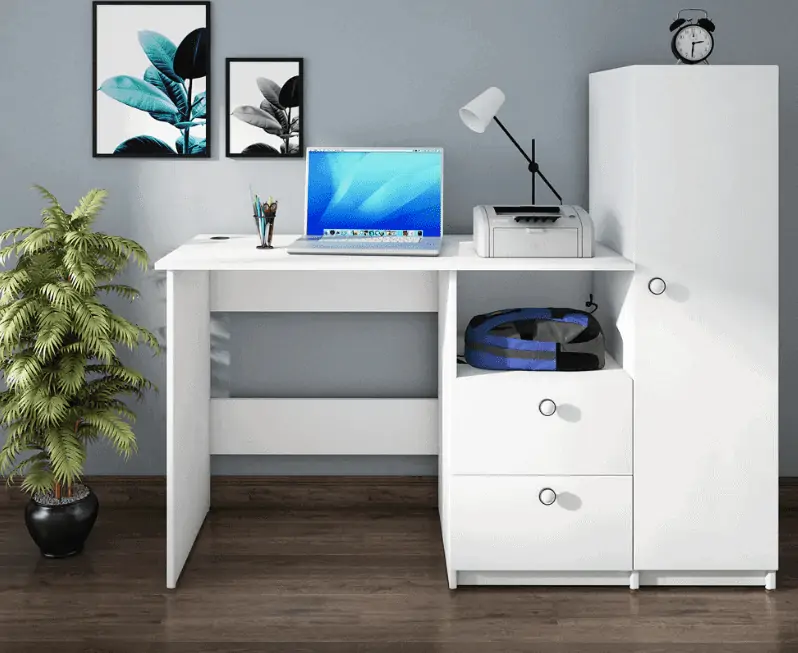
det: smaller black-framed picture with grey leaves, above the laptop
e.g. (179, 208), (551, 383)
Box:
(227, 59), (305, 158)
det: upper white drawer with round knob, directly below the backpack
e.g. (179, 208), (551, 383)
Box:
(451, 358), (633, 475)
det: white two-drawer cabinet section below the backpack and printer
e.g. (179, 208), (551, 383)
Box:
(440, 296), (636, 587)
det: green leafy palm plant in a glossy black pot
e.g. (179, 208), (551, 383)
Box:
(0, 187), (159, 557)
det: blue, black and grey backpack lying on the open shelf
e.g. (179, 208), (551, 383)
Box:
(465, 308), (604, 372)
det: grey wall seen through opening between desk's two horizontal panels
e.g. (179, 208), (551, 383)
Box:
(219, 313), (438, 399)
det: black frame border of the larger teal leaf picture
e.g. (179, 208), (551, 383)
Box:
(92, 0), (214, 160)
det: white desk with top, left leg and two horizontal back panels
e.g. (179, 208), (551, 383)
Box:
(155, 235), (634, 588)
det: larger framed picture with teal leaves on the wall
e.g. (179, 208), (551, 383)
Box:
(92, 2), (212, 158)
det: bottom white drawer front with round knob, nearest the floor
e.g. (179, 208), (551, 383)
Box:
(449, 476), (632, 571)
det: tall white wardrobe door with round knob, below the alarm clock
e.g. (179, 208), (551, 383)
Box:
(630, 66), (779, 570)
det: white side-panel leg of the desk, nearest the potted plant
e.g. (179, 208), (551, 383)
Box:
(166, 271), (211, 589)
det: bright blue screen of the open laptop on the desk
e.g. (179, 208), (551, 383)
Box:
(307, 148), (443, 237)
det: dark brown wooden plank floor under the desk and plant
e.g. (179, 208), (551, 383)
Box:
(0, 492), (798, 653)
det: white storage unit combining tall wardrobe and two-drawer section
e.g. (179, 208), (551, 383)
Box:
(441, 66), (779, 589)
